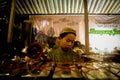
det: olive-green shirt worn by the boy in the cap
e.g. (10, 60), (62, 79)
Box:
(48, 47), (81, 62)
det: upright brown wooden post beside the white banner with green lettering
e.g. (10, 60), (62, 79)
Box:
(83, 0), (89, 54)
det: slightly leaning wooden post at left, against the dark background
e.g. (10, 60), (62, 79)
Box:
(7, 0), (16, 43)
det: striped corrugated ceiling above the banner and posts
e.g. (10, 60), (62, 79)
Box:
(0, 0), (120, 15)
